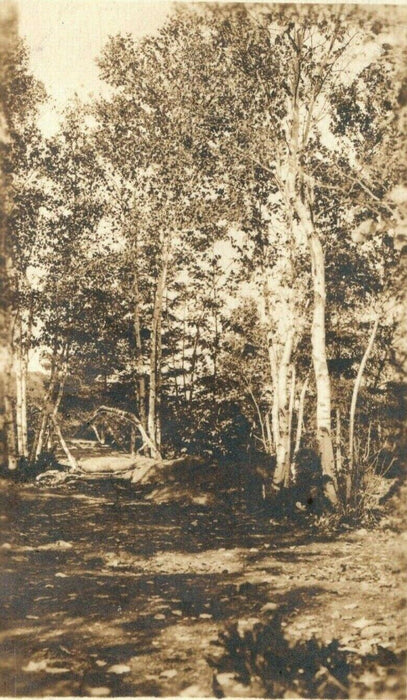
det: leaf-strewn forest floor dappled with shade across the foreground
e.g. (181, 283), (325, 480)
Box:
(0, 474), (407, 700)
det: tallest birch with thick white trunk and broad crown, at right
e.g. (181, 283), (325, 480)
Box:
(159, 0), (404, 502)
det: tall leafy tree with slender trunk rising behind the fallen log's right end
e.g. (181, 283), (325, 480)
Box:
(95, 27), (231, 449)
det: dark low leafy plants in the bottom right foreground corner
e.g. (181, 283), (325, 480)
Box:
(207, 614), (403, 699)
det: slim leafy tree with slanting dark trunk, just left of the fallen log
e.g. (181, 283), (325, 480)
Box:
(30, 103), (107, 461)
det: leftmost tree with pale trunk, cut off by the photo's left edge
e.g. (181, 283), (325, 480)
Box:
(1, 24), (45, 469)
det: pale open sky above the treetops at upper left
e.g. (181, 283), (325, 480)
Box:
(17, 0), (172, 132)
